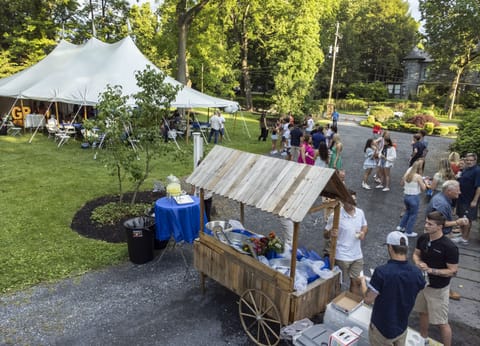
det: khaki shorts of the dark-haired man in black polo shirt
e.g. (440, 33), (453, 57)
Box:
(413, 285), (450, 325)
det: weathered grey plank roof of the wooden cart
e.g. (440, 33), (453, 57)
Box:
(187, 145), (351, 222)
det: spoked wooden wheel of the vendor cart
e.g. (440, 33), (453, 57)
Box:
(238, 289), (281, 346)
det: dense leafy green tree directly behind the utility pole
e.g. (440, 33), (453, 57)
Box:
(319, 0), (419, 95)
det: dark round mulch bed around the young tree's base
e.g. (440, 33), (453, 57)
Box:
(71, 191), (165, 243)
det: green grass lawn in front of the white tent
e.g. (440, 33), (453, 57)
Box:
(0, 113), (271, 293)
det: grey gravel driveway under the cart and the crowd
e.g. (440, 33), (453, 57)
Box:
(0, 117), (480, 346)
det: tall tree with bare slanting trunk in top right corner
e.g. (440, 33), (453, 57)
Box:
(419, 0), (480, 119)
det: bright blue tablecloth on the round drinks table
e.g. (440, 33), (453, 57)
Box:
(155, 196), (207, 243)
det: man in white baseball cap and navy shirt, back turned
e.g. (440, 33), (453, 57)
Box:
(364, 231), (426, 345)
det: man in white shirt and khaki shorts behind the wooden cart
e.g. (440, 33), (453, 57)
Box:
(324, 191), (368, 296)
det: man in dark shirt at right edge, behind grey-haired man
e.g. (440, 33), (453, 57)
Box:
(452, 153), (480, 245)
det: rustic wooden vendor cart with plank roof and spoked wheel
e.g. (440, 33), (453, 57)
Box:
(187, 146), (352, 345)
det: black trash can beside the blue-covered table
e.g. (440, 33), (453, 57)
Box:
(123, 216), (155, 264)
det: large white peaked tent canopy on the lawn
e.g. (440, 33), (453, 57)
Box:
(0, 37), (238, 110)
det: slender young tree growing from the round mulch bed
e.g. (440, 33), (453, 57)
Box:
(86, 66), (179, 204)
